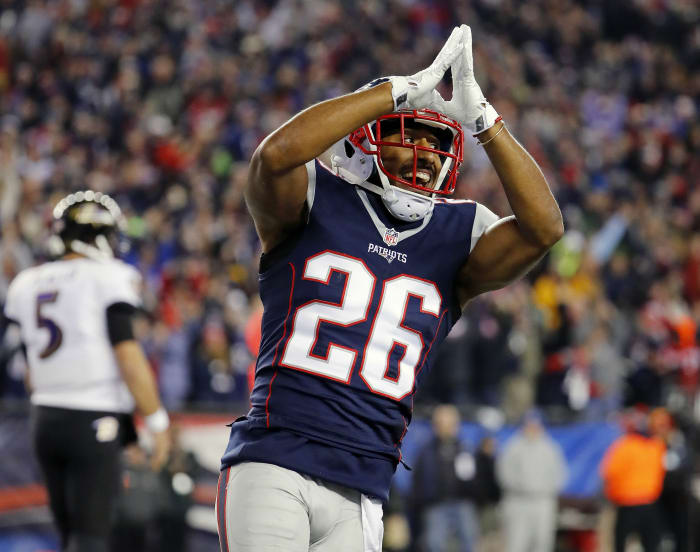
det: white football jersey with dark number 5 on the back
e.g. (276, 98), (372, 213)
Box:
(5, 258), (141, 412)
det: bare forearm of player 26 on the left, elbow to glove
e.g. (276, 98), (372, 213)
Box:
(260, 83), (394, 173)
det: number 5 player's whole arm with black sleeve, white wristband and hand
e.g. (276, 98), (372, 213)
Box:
(107, 303), (170, 469)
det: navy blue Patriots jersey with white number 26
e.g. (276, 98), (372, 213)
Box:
(222, 158), (495, 500)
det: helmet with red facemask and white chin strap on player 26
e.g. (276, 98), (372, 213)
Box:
(331, 109), (464, 222)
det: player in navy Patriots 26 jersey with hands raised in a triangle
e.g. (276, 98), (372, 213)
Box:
(217, 25), (563, 552)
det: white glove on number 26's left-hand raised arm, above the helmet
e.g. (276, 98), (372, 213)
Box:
(378, 25), (469, 111)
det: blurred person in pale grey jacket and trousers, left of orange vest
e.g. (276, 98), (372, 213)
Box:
(496, 412), (568, 552)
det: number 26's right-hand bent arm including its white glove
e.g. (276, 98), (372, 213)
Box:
(435, 25), (564, 305)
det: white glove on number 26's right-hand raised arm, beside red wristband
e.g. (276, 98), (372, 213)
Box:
(431, 25), (500, 134)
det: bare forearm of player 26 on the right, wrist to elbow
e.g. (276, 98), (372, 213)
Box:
(478, 123), (564, 247)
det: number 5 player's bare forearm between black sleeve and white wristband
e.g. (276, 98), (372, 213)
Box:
(114, 340), (161, 416)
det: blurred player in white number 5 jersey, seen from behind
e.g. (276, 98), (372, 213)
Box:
(5, 191), (169, 552)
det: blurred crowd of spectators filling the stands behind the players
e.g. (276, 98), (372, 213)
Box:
(0, 0), (700, 550)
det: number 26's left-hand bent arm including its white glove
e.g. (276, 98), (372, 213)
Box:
(245, 28), (470, 252)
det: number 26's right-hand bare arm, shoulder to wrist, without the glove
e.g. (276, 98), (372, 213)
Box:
(457, 123), (564, 306)
